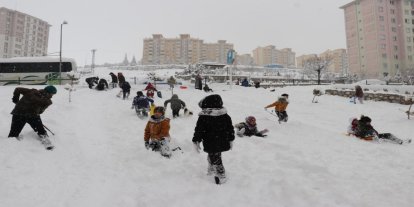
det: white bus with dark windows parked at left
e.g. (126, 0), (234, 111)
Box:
(0, 57), (79, 85)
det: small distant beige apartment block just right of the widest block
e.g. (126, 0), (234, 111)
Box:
(252, 45), (296, 67)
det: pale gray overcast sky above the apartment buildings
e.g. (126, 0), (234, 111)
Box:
(0, 0), (352, 65)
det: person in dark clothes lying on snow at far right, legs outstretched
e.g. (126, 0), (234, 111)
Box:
(348, 115), (411, 144)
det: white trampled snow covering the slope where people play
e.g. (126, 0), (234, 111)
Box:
(0, 69), (414, 207)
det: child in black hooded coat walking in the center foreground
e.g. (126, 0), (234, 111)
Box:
(193, 94), (234, 184)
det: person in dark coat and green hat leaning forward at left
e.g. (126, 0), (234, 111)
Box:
(9, 86), (57, 142)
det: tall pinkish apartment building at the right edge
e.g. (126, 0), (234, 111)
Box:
(340, 0), (414, 78)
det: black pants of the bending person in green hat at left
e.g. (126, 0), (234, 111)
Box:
(9, 115), (47, 137)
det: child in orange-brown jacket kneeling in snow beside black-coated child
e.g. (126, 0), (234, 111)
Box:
(144, 106), (171, 158)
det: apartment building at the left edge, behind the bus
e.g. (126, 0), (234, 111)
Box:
(0, 7), (50, 58)
